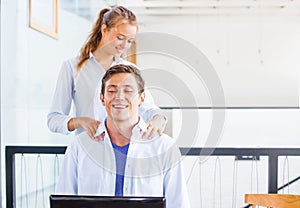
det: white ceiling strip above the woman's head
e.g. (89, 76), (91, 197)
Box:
(60, 0), (300, 21)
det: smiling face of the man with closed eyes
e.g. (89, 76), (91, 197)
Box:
(100, 73), (145, 124)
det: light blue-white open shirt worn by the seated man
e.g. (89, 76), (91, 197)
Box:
(56, 119), (190, 208)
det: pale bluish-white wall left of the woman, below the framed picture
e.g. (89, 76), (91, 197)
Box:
(1, 0), (91, 207)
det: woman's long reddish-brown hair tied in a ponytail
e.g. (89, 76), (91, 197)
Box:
(77, 6), (137, 72)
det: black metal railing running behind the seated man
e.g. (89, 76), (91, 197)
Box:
(5, 146), (300, 208)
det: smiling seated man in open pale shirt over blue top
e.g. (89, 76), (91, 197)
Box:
(56, 65), (190, 208)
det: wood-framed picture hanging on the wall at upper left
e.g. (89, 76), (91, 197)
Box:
(29, 0), (58, 39)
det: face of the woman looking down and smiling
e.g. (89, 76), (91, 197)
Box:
(100, 23), (137, 56)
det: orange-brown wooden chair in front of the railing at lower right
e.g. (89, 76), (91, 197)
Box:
(245, 194), (300, 208)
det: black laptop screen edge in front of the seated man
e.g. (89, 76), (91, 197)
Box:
(50, 195), (166, 208)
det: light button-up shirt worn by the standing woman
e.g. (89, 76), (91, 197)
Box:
(47, 53), (162, 134)
